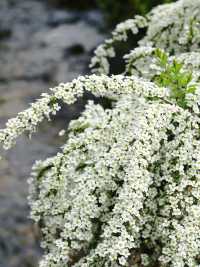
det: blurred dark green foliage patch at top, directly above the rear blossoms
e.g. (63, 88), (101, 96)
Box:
(96, 0), (173, 27)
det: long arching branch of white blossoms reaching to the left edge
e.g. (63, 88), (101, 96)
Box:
(0, 74), (166, 149)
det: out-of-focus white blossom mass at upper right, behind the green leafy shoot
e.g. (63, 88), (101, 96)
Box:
(90, 0), (200, 74)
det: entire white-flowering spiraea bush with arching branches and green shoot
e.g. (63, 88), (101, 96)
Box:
(0, 0), (200, 267)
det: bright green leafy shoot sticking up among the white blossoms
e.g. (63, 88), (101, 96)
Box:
(154, 49), (196, 108)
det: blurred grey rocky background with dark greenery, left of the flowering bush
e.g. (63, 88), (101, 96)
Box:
(0, 0), (173, 267)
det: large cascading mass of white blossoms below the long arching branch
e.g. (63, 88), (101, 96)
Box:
(27, 86), (200, 267)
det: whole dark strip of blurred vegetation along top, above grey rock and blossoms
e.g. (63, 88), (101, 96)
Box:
(48, 0), (174, 28)
